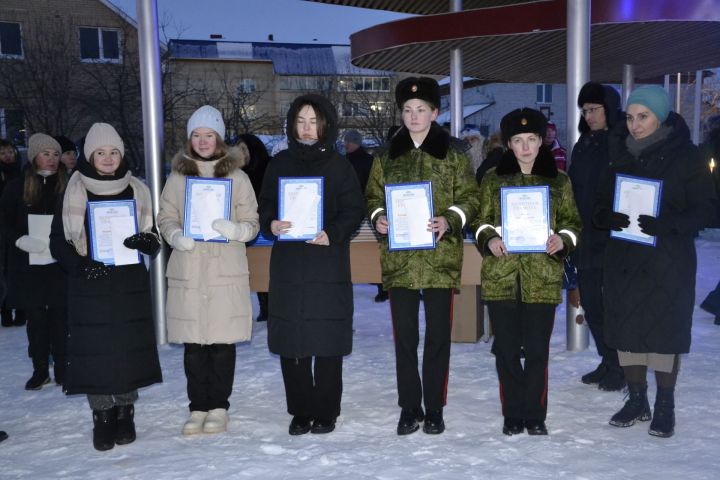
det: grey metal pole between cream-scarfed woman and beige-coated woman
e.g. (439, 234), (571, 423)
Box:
(137, 0), (167, 345)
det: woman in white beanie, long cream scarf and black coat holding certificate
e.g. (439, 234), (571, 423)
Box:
(50, 123), (162, 450)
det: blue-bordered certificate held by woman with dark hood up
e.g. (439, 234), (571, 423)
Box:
(278, 177), (323, 241)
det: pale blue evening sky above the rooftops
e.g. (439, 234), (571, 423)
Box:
(110, 0), (407, 44)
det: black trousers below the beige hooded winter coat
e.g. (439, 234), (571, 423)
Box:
(184, 343), (236, 412)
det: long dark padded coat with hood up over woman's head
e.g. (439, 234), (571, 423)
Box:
(259, 95), (365, 358)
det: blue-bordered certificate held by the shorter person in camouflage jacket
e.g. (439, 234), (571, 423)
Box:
(500, 185), (550, 253)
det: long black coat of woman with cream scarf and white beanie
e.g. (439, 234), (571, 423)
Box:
(50, 165), (162, 394)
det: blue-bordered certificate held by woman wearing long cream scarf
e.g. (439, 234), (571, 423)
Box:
(87, 200), (140, 265)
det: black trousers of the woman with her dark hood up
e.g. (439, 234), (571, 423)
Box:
(280, 356), (343, 420)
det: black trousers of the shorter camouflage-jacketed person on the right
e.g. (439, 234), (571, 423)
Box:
(487, 300), (555, 420)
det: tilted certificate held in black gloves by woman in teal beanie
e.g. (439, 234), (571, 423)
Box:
(610, 174), (662, 246)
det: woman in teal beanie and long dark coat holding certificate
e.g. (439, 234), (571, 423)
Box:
(593, 86), (715, 437)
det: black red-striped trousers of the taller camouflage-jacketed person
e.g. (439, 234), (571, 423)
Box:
(388, 288), (455, 410)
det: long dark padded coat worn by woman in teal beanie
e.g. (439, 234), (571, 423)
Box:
(595, 112), (715, 354)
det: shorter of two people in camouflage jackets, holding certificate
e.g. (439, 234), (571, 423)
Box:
(473, 108), (581, 435)
